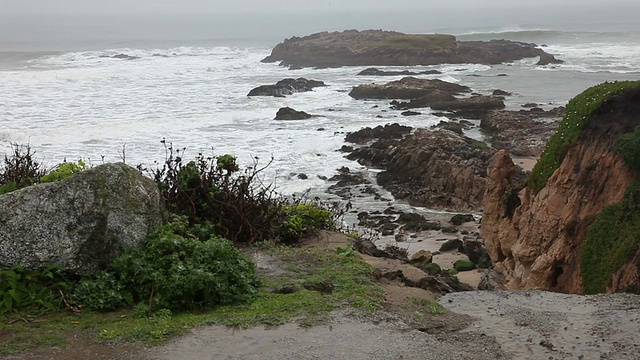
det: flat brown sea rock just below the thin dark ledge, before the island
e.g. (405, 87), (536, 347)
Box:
(349, 77), (471, 99)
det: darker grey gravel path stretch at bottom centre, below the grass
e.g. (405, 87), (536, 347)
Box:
(145, 312), (509, 360)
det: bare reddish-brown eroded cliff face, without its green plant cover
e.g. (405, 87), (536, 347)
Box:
(482, 90), (640, 293)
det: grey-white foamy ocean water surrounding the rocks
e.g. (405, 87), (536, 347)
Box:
(0, 7), (640, 219)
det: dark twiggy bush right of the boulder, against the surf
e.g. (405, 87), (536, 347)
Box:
(152, 142), (342, 243)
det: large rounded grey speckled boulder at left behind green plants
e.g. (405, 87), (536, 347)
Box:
(0, 163), (164, 274)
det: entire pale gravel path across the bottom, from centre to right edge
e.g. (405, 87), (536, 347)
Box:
(144, 291), (640, 360)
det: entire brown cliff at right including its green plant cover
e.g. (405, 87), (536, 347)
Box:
(482, 82), (640, 293)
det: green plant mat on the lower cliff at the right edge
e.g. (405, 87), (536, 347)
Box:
(580, 182), (640, 294)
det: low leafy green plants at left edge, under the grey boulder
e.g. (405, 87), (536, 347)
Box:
(0, 266), (69, 314)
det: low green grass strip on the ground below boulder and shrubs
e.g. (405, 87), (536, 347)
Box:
(0, 246), (382, 355)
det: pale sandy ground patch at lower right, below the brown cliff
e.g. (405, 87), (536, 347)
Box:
(440, 291), (640, 360)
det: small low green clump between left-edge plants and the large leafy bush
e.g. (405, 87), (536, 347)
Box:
(69, 271), (131, 311)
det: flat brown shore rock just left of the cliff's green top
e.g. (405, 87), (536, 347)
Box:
(480, 107), (564, 157)
